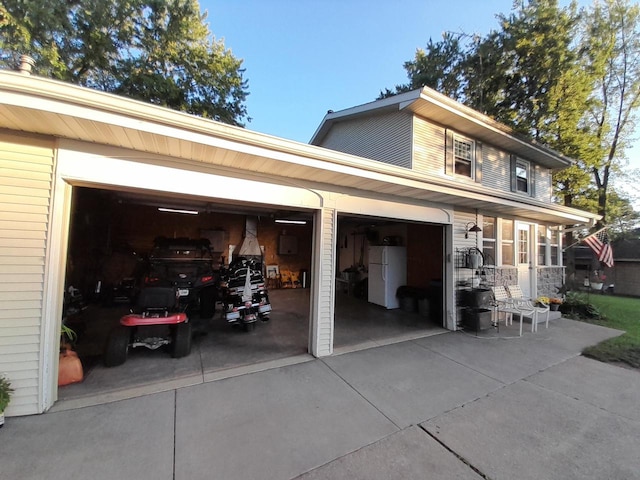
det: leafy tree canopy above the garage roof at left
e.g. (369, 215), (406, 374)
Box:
(0, 0), (249, 126)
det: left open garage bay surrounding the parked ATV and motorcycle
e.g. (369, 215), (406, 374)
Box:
(58, 187), (313, 400)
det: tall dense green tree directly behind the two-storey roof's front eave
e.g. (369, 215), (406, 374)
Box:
(482, 0), (579, 142)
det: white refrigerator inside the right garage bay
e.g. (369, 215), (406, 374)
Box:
(369, 246), (407, 309)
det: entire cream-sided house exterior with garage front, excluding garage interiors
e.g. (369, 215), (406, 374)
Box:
(0, 71), (596, 415)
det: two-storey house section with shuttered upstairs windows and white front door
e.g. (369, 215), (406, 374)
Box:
(310, 88), (596, 298)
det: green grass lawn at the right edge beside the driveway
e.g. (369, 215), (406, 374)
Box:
(582, 295), (640, 368)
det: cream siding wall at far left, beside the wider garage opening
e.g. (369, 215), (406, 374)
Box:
(0, 137), (53, 415)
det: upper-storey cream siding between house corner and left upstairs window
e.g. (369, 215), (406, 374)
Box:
(413, 116), (445, 175)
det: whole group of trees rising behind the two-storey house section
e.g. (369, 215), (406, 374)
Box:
(380, 0), (640, 234)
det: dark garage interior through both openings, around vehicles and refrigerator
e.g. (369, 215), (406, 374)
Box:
(58, 187), (445, 400)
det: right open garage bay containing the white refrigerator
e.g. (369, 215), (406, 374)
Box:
(334, 215), (445, 352)
